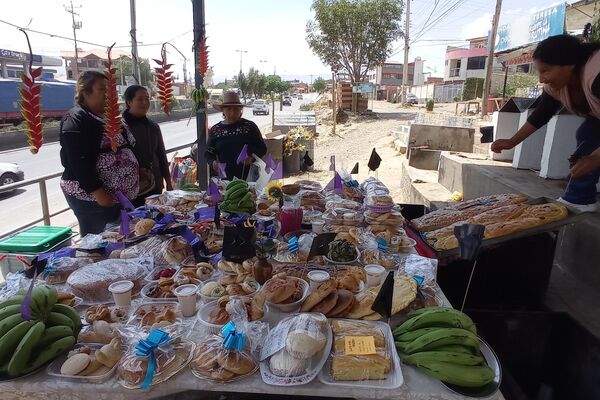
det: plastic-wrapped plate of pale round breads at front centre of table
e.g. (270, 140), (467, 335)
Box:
(260, 313), (332, 386)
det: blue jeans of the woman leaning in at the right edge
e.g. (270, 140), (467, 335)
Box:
(563, 118), (600, 204)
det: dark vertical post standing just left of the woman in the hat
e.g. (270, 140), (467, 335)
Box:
(192, 0), (208, 190)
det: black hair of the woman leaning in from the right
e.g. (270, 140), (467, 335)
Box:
(533, 35), (600, 68)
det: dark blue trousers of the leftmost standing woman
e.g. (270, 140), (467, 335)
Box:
(65, 194), (120, 237)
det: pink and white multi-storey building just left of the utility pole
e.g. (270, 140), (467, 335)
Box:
(444, 36), (488, 82)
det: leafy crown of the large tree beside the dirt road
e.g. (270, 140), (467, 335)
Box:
(306, 0), (403, 83)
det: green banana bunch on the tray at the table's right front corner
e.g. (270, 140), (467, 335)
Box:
(393, 307), (495, 387)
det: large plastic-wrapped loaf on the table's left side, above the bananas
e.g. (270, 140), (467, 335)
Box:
(67, 257), (154, 304)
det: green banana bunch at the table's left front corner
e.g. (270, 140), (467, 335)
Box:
(0, 285), (82, 377)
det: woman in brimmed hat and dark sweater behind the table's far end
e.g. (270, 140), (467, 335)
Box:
(204, 91), (267, 180)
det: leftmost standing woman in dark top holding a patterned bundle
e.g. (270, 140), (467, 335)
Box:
(60, 71), (138, 236)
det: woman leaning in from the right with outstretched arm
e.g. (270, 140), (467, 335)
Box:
(491, 35), (600, 212)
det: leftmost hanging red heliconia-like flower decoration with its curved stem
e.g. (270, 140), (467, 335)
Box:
(18, 30), (44, 154)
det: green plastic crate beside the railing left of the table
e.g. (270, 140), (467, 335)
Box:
(0, 226), (71, 253)
